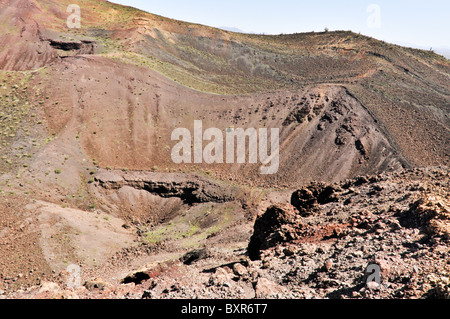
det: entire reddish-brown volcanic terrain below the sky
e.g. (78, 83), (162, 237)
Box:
(0, 0), (450, 298)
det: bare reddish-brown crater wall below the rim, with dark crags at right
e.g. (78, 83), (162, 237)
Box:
(27, 56), (409, 187)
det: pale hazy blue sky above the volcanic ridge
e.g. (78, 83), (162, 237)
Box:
(113, 0), (450, 49)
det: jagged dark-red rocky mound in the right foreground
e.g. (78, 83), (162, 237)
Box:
(248, 167), (450, 299)
